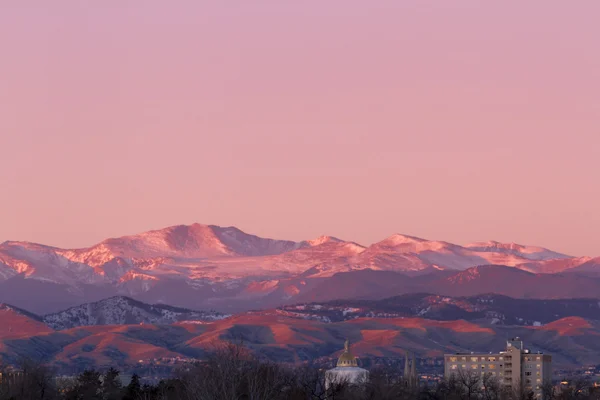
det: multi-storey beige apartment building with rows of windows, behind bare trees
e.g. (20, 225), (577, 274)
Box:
(444, 337), (552, 398)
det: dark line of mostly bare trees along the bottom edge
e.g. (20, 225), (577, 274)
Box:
(0, 344), (600, 400)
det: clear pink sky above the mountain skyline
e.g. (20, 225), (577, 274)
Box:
(0, 0), (600, 255)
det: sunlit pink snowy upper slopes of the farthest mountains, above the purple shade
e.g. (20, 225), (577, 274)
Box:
(0, 224), (580, 293)
